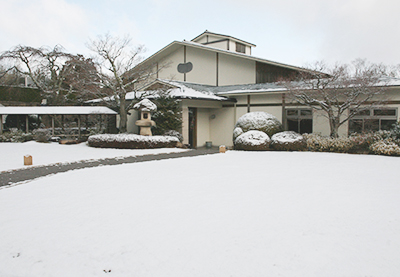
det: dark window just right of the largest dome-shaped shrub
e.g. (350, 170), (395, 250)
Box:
(286, 109), (313, 134)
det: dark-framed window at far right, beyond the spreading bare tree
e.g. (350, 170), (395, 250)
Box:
(349, 108), (397, 134)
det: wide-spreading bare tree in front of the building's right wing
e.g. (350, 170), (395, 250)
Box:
(282, 60), (393, 137)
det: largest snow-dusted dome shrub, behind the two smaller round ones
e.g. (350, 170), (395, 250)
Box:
(233, 112), (282, 141)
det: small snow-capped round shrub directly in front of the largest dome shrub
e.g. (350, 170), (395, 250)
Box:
(235, 130), (271, 151)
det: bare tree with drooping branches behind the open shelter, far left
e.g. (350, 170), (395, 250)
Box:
(0, 45), (91, 104)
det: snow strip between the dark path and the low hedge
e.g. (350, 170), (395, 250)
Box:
(0, 141), (187, 172)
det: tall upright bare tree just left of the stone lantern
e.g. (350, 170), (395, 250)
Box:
(88, 34), (161, 133)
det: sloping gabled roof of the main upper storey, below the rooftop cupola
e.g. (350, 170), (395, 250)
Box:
(137, 41), (311, 72)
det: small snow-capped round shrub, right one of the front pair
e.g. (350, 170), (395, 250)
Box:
(271, 131), (307, 151)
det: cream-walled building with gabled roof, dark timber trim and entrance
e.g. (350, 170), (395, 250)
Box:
(127, 31), (400, 147)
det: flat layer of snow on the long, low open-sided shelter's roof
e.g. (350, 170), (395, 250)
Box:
(0, 106), (117, 115)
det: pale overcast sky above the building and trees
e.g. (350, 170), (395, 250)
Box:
(0, 0), (400, 66)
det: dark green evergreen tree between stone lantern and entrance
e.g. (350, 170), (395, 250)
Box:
(152, 91), (182, 135)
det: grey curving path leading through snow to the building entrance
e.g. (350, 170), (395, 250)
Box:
(0, 147), (219, 187)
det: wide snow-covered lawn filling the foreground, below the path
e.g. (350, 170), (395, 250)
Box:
(0, 151), (400, 277)
